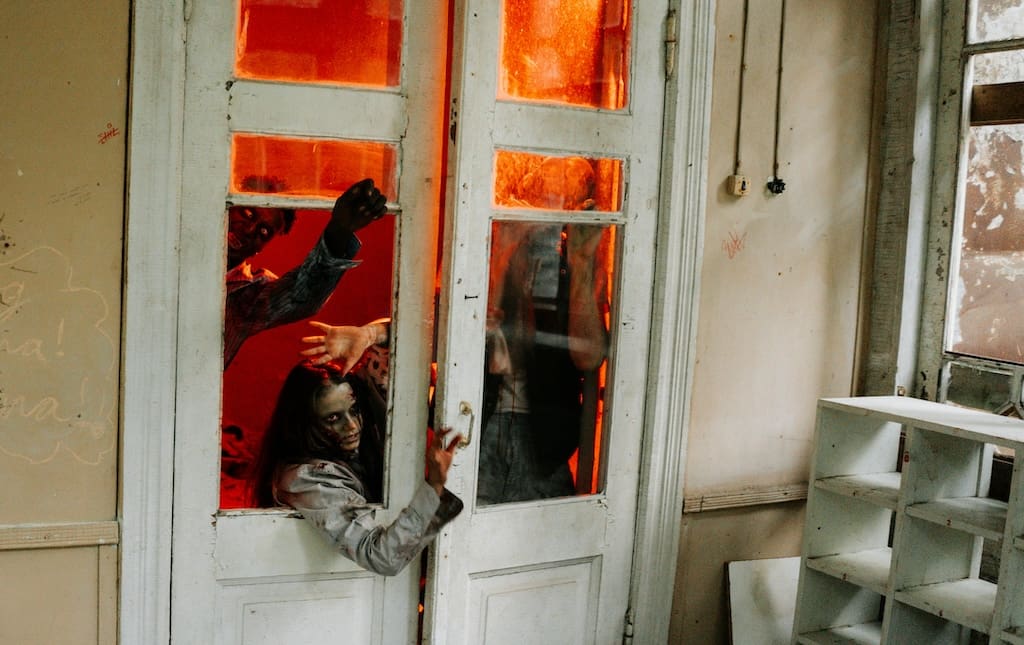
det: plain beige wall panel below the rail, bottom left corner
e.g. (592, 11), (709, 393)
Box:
(0, 547), (117, 645)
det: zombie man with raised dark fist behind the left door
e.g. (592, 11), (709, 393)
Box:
(224, 177), (387, 370)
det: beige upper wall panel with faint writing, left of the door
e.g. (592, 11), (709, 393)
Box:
(0, 0), (129, 524)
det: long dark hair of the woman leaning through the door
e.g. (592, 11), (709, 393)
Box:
(250, 360), (384, 508)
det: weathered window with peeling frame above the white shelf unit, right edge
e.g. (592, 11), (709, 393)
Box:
(926, 0), (1024, 416)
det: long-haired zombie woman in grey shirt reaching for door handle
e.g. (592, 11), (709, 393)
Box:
(252, 360), (463, 575)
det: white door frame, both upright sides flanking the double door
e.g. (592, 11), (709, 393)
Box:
(120, 0), (715, 644)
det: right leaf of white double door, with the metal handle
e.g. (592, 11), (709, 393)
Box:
(427, 0), (667, 645)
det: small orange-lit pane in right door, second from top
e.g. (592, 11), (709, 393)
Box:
(495, 151), (623, 211)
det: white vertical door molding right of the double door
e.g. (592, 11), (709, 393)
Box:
(628, 0), (715, 643)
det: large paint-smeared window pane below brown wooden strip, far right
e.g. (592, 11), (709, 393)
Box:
(948, 124), (1024, 363)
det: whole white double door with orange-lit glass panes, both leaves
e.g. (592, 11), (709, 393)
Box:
(171, 0), (667, 645)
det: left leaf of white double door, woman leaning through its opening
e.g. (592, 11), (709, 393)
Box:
(172, 0), (447, 645)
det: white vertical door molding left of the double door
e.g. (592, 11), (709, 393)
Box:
(119, 0), (185, 644)
